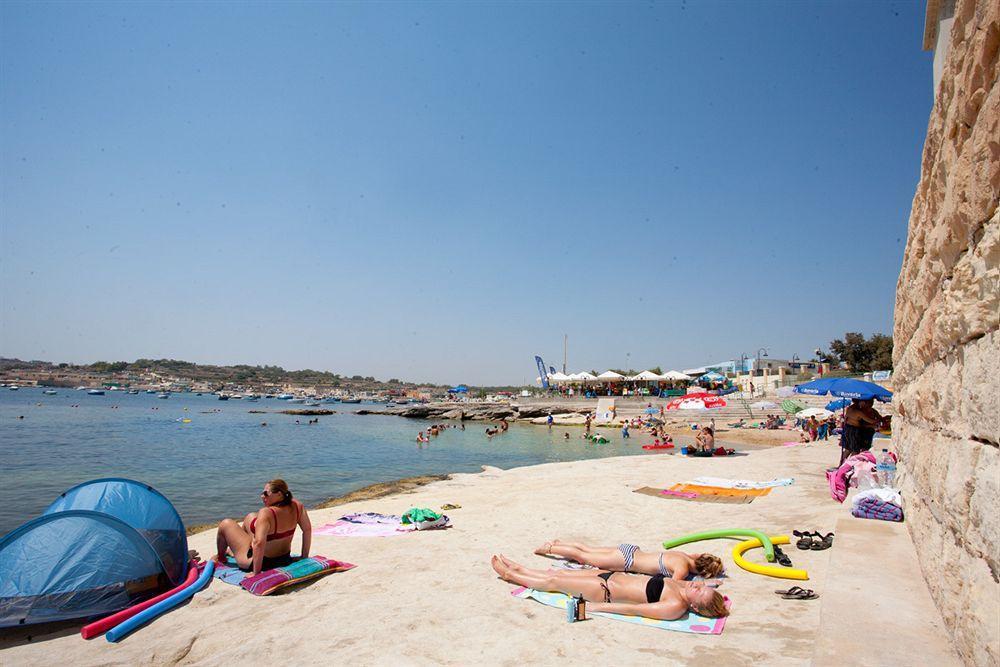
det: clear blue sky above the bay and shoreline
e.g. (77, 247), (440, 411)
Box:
(0, 1), (932, 384)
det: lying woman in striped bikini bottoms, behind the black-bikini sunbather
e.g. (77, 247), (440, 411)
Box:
(535, 540), (722, 581)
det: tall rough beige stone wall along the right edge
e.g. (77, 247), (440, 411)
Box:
(893, 0), (1000, 665)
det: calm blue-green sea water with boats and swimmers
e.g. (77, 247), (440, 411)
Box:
(0, 387), (688, 534)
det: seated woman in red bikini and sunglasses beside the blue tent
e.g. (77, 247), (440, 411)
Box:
(215, 479), (312, 574)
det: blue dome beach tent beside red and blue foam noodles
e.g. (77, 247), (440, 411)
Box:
(0, 478), (188, 628)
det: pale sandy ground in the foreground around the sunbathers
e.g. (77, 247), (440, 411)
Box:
(0, 444), (957, 665)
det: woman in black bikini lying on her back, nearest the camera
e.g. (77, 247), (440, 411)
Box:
(491, 556), (729, 621)
